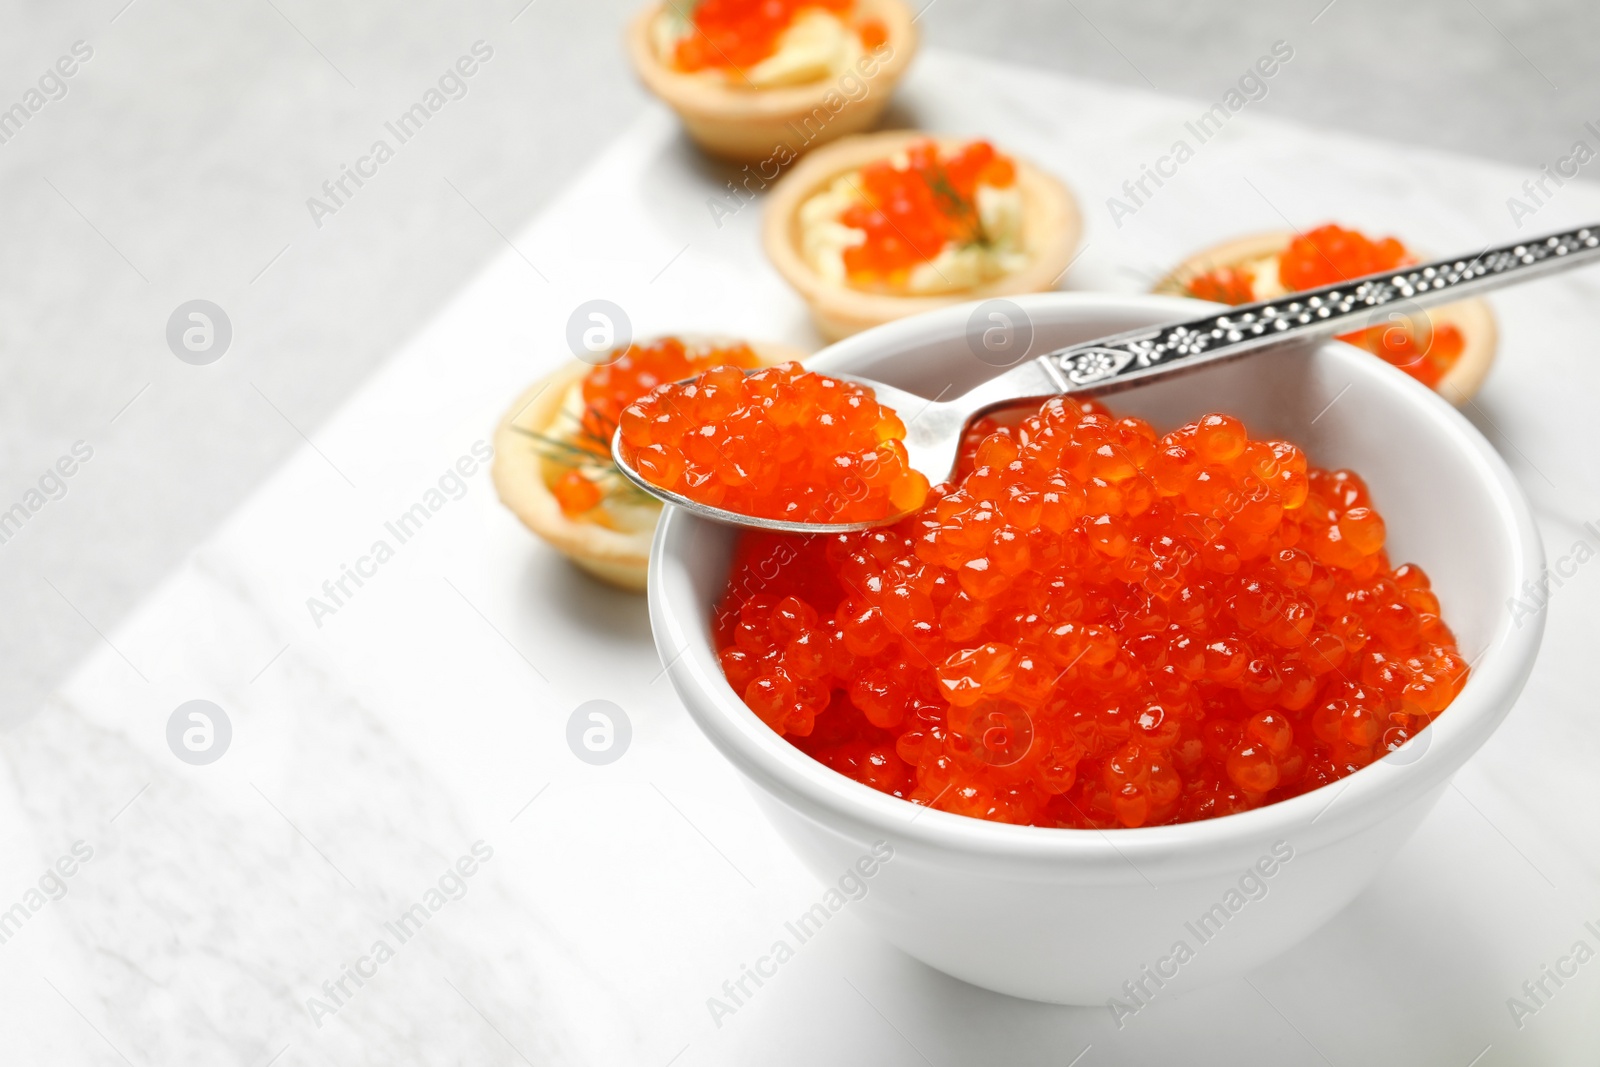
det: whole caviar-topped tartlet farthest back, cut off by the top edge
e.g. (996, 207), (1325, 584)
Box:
(627, 0), (917, 163)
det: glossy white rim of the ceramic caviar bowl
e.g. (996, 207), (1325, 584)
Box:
(650, 293), (1544, 867)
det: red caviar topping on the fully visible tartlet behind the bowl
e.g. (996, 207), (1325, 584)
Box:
(838, 139), (1016, 285)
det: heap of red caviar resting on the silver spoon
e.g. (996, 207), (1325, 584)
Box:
(621, 363), (928, 523)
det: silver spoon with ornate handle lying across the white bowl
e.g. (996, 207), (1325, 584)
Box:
(611, 224), (1600, 534)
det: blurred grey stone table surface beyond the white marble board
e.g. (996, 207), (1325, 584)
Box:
(0, 0), (1600, 721)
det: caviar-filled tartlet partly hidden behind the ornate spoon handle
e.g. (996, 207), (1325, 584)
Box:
(1155, 222), (1499, 403)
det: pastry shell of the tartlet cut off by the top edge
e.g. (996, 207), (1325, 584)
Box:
(626, 0), (917, 163)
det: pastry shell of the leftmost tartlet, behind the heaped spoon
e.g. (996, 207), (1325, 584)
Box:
(491, 334), (806, 592)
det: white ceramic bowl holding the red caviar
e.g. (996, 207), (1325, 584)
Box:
(650, 293), (1544, 1013)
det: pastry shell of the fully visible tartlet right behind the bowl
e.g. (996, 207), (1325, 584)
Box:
(762, 130), (1083, 341)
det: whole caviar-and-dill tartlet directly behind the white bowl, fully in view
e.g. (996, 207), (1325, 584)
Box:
(762, 130), (1082, 341)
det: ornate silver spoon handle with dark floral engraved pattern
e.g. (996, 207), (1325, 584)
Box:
(1038, 224), (1600, 392)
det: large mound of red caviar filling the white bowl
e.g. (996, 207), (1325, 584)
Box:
(714, 398), (1467, 829)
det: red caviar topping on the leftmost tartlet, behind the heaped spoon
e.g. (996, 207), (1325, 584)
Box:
(549, 338), (760, 518)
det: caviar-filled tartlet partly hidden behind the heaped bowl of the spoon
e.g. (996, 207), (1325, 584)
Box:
(493, 336), (802, 592)
